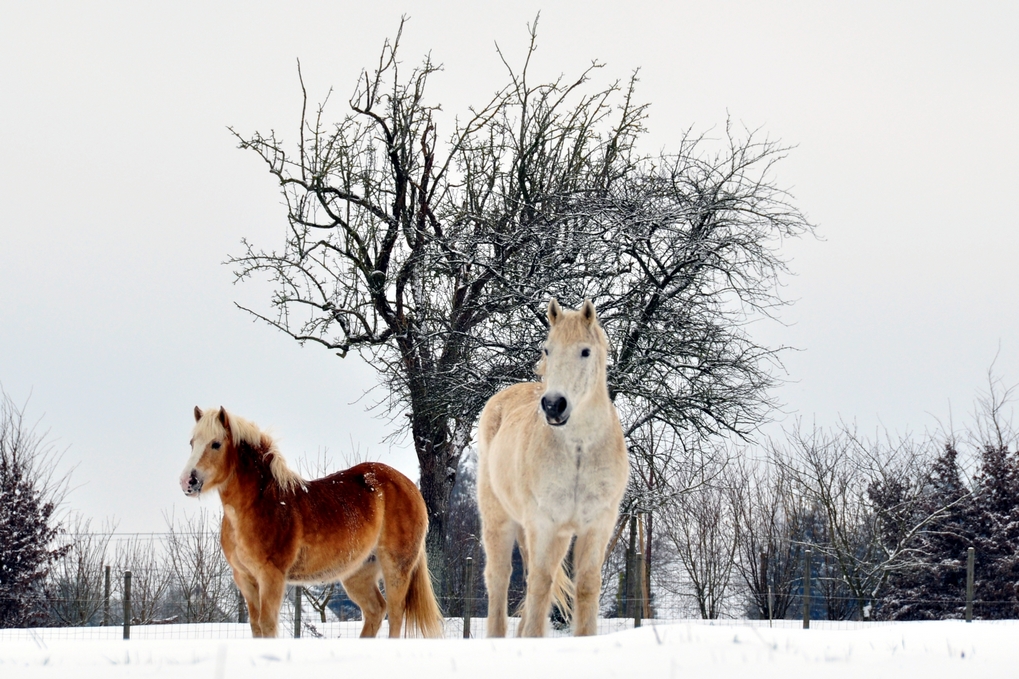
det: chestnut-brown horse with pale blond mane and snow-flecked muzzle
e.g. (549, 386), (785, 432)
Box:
(180, 406), (442, 637)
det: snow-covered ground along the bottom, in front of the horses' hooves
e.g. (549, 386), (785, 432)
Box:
(0, 621), (1019, 679)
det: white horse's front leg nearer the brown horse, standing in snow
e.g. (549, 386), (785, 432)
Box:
(520, 524), (572, 636)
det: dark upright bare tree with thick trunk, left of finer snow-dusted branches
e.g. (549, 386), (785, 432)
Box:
(231, 18), (642, 567)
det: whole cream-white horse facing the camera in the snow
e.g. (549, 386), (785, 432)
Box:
(478, 300), (630, 636)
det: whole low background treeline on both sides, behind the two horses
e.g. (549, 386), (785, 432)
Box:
(7, 383), (1019, 627)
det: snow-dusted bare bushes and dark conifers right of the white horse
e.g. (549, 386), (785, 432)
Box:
(606, 383), (1019, 620)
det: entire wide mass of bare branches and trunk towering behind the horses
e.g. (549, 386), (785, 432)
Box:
(230, 15), (810, 579)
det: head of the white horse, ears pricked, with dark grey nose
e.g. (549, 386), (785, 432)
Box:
(539, 300), (608, 426)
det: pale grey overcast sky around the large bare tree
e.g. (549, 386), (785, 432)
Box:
(0, 0), (1019, 531)
